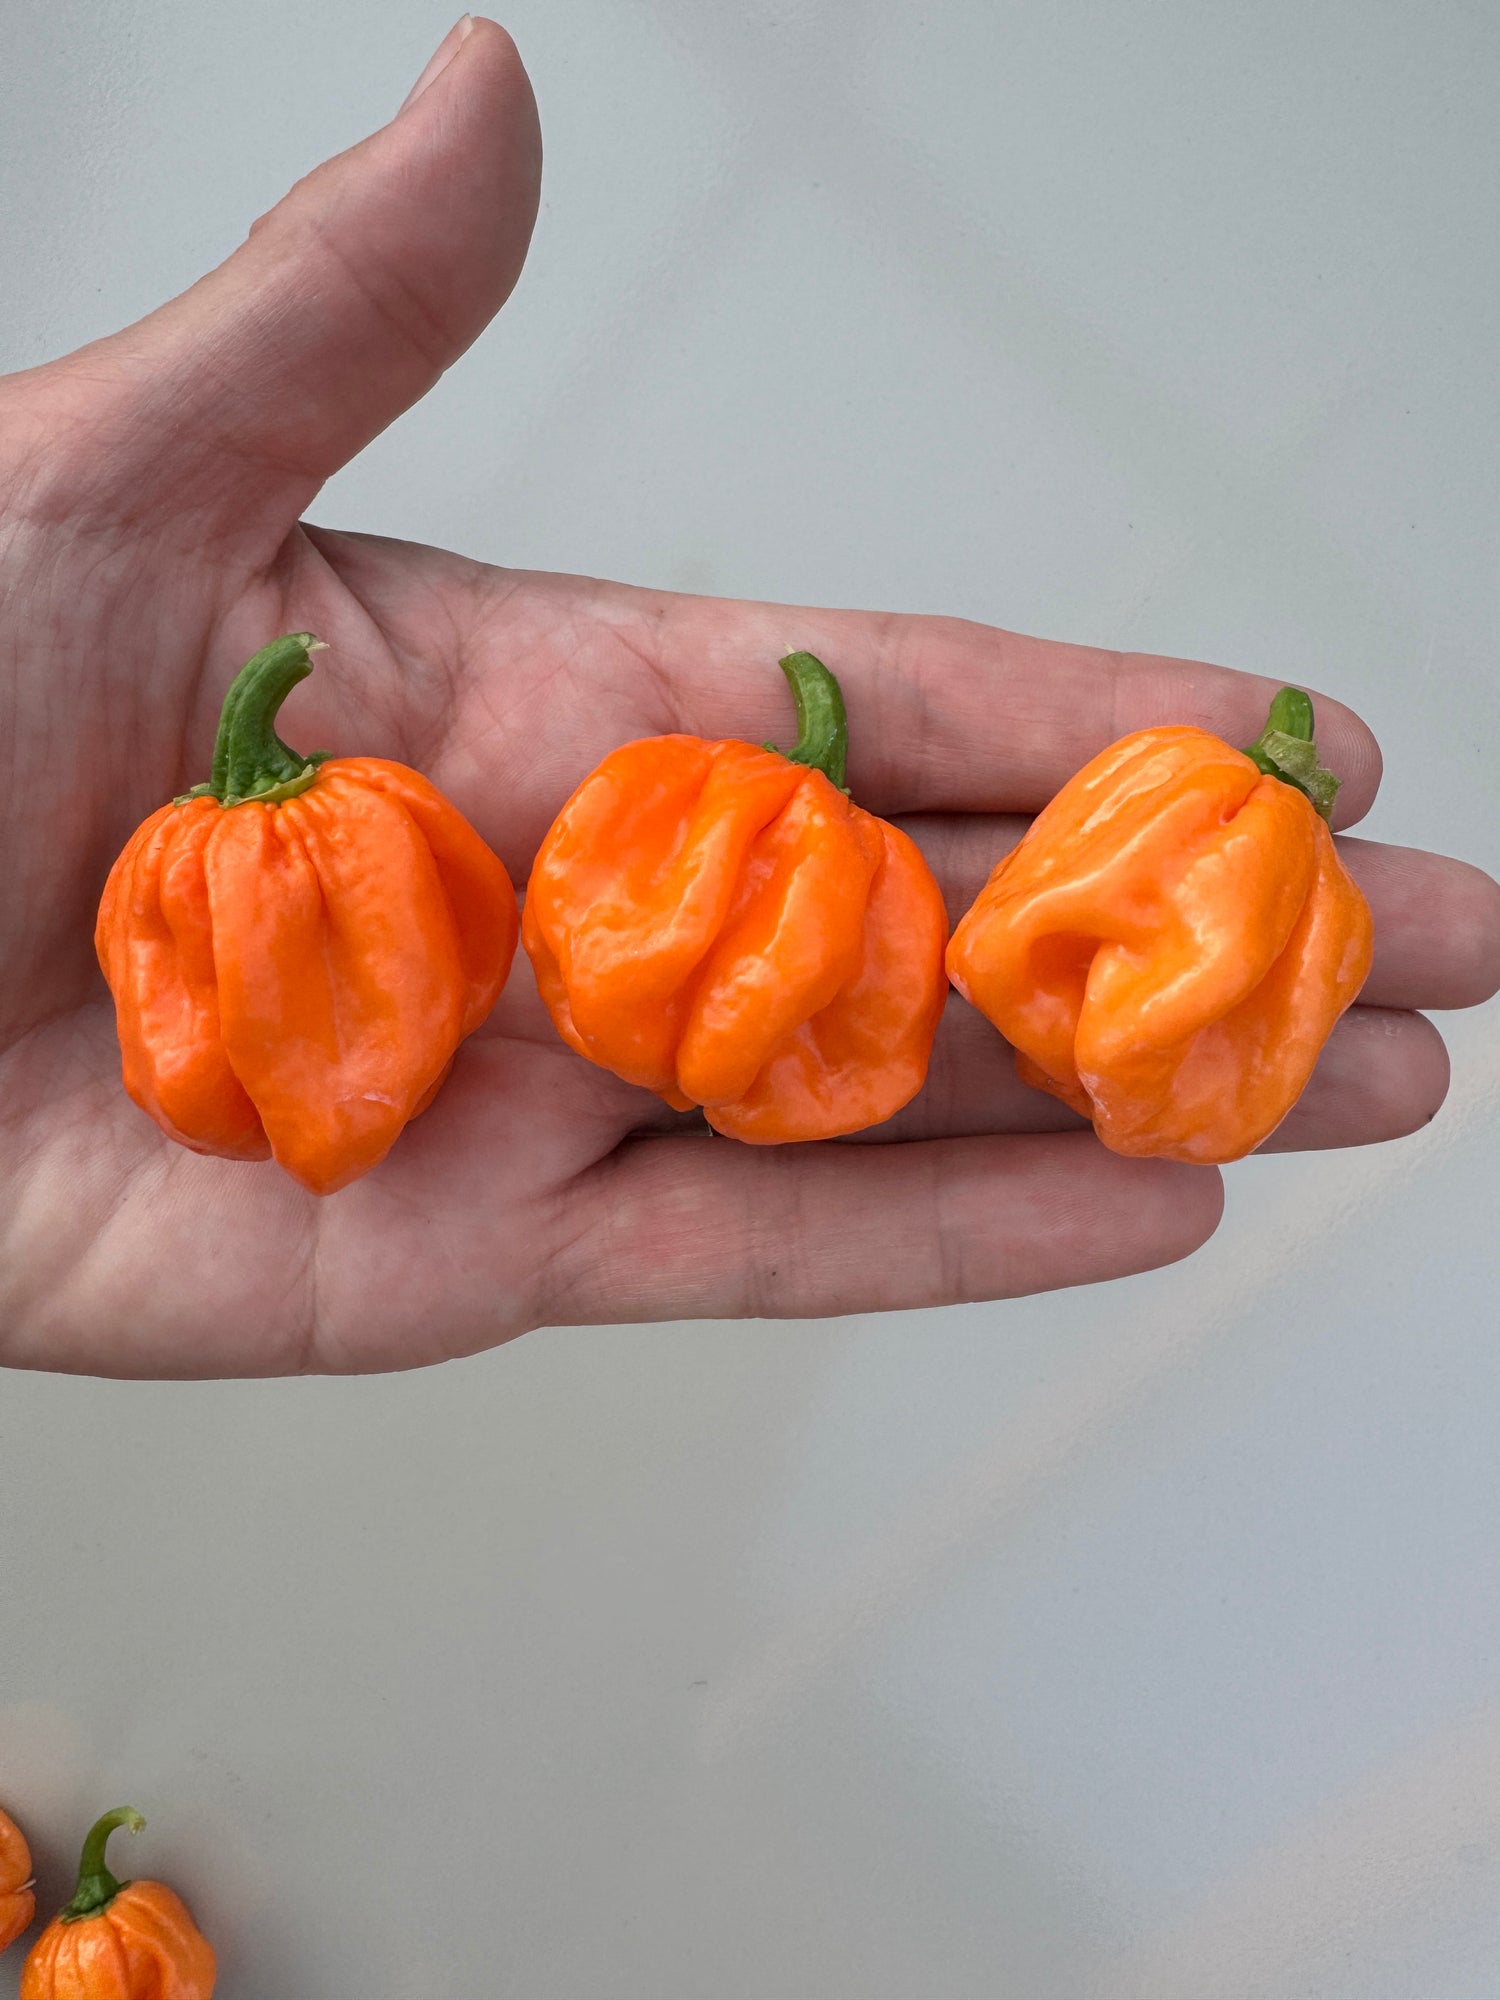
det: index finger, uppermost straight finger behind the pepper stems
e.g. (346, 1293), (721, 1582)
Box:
(648, 592), (1380, 826)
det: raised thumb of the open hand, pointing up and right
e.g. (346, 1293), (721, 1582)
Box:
(38, 16), (542, 554)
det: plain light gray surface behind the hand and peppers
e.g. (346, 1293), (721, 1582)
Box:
(0, 0), (1500, 2000)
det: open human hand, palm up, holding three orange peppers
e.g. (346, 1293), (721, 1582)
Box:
(0, 22), (1500, 1376)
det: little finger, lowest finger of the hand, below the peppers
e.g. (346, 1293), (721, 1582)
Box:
(550, 1134), (1222, 1324)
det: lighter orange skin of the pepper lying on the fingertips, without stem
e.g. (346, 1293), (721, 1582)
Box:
(948, 728), (1372, 1164)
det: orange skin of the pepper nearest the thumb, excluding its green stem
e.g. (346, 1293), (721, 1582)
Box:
(94, 758), (520, 1194)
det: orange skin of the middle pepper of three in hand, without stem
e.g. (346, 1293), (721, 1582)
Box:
(522, 736), (948, 1146)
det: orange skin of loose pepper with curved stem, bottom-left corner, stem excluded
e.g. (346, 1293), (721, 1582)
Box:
(20, 1882), (216, 2000)
